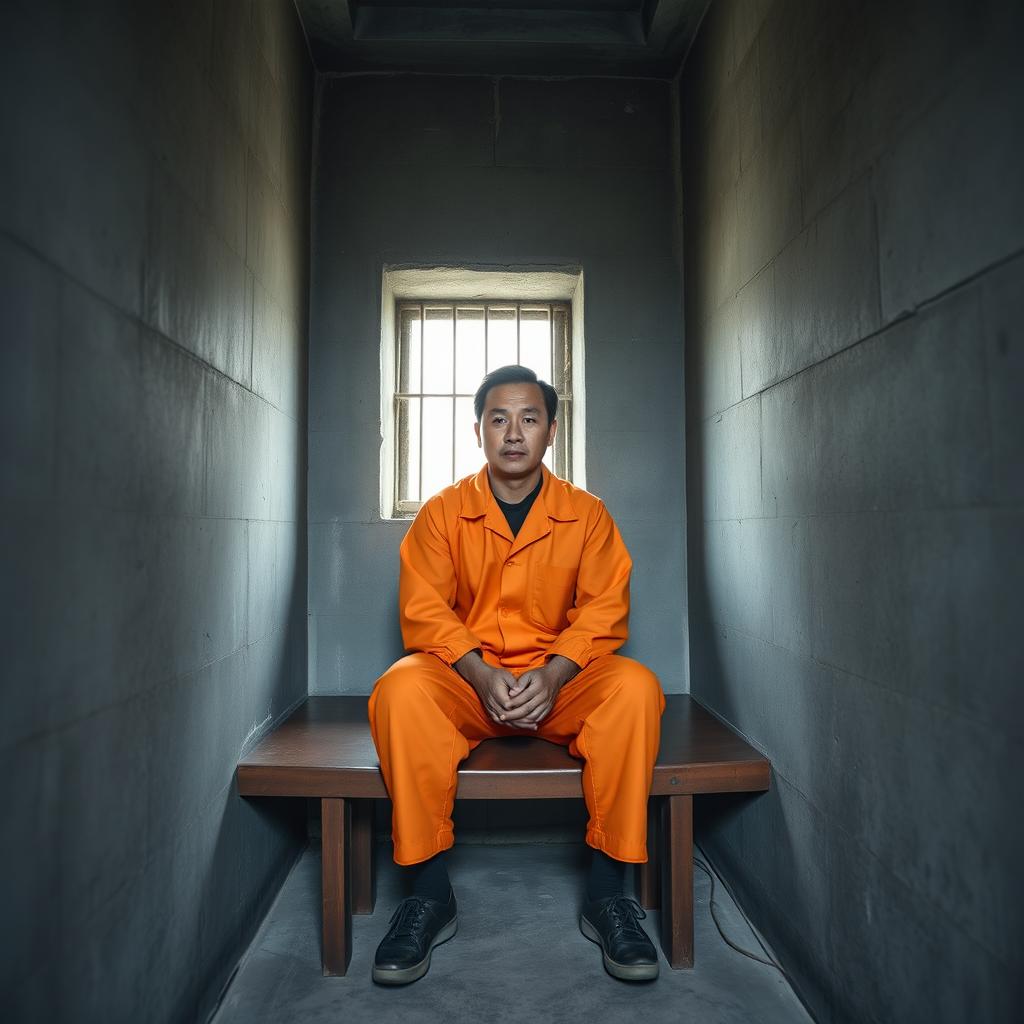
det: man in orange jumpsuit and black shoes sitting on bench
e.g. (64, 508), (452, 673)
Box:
(370, 366), (665, 984)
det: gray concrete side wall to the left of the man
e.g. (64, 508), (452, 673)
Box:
(0, 0), (311, 1024)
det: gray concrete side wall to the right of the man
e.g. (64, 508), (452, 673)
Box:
(680, 0), (1024, 1024)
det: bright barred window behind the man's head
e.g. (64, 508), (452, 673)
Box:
(394, 300), (572, 516)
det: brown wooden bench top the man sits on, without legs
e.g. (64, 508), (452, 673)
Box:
(238, 693), (771, 800)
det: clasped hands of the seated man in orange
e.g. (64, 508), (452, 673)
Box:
(453, 650), (580, 731)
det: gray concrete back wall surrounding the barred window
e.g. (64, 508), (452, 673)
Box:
(309, 76), (686, 693)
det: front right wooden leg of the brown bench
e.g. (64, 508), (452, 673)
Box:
(662, 795), (693, 969)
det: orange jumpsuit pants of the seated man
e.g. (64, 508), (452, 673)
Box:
(370, 653), (665, 864)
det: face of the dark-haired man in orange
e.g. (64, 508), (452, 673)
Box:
(475, 384), (558, 480)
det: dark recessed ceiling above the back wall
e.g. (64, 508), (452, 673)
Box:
(296, 0), (710, 78)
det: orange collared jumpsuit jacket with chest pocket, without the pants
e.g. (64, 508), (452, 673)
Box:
(398, 466), (633, 675)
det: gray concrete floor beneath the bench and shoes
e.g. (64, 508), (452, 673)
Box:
(214, 844), (810, 1024)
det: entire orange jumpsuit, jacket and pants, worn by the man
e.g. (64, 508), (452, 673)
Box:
(370, 466), (665, 864)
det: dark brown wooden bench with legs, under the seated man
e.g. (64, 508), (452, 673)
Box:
(238, 694), (771, 975)
